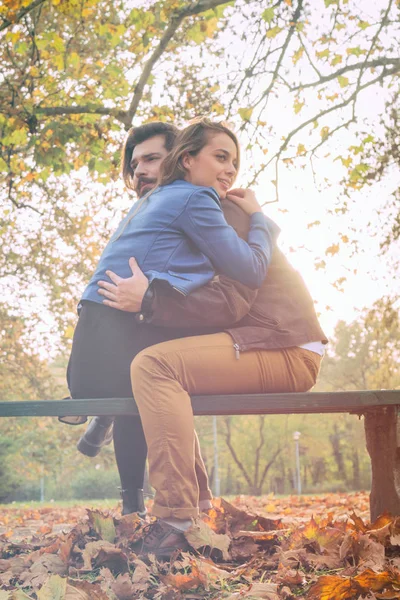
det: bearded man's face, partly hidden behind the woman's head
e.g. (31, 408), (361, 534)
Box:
(131, 135), (168, 198)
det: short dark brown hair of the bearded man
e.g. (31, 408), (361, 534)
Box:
(121, 121), (179, 190)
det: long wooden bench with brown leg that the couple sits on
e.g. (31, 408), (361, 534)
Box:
(0, 390), (400, 520)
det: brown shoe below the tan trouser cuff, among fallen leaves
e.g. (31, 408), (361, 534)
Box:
(139, 519), (190, 559)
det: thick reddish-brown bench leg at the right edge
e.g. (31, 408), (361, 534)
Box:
(364, 406), (400, 522)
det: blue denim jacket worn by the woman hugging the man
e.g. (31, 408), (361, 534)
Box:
(82, 180), (279, 303)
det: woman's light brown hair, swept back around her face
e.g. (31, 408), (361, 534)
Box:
(158, 117), (240, 185)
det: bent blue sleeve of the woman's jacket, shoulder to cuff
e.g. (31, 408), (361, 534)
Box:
(180, 188), (279, 289)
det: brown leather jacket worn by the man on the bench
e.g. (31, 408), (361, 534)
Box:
(137, 201), (328, 351)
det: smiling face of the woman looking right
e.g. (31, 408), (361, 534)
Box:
(182, 132), (238, 198)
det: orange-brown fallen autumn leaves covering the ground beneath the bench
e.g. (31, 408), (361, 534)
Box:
(0, 493), (400, 600)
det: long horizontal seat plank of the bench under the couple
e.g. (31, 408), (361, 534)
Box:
(0, 390), (400, 417)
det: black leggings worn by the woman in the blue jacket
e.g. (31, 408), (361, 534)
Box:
(67, 302), (214, 489)
